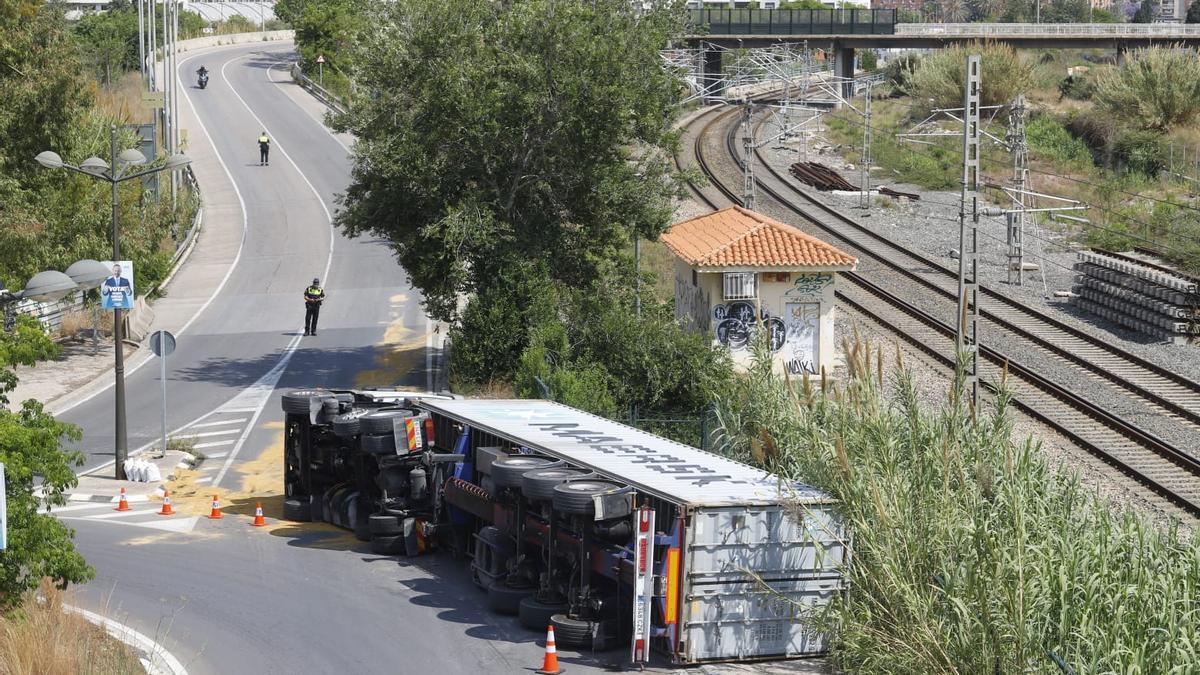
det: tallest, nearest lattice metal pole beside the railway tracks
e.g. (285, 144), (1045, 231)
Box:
(958, 54), (980, 411)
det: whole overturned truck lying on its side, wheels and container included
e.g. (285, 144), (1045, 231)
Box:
(283, 390), (851, 664)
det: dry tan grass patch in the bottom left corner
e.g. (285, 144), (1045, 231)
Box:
(0, 581), (145, 675)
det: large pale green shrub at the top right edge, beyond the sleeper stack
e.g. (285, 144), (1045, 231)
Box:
(1093, 47), (1200, 131)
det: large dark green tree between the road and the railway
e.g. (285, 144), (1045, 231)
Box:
(335, 0), (683, 321)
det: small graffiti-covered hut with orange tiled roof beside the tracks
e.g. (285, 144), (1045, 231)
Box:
(662, 207), (858, 375)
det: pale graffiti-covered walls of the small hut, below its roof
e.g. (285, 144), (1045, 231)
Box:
(676, 263), (835, 375)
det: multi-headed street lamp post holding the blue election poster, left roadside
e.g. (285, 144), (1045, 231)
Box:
(36, 124), (192, 480)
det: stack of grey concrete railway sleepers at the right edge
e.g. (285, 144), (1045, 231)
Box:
(1073, 251), (1200, 342)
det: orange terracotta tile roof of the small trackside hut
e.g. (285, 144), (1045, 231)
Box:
(662, 207), (858, 269)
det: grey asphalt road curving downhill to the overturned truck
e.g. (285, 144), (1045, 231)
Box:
(62, 43), (667, 675)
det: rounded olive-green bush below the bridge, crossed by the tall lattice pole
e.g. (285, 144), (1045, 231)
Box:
(906, 42), (1033, 108)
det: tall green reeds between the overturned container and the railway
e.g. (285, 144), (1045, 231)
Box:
(718, 341), (1200, 674)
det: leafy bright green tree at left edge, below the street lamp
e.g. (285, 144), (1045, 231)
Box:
(0, 317), (95, 610)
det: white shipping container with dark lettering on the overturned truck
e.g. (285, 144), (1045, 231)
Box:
(418, 400), (851, 664)
